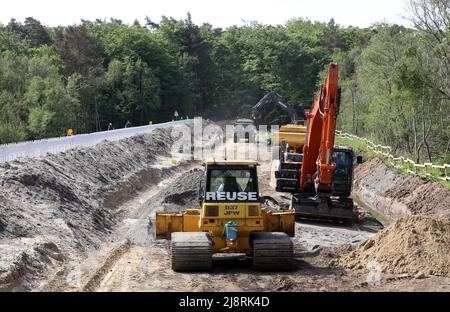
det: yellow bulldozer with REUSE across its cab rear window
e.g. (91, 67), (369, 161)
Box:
(156, 160), (295, 271)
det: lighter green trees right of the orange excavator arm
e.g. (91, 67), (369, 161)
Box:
(337, 0), (450, 163)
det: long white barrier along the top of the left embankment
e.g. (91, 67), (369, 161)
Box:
(0, 119), (192, 163)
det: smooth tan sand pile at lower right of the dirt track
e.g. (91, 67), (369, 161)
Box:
(332, 215), (450, 277)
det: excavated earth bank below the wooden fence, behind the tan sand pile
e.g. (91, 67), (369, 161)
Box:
(353, 158), (450, 220)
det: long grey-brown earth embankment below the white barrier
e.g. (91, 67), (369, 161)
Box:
(0, 129), (179, 290)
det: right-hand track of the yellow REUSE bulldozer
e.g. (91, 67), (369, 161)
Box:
(250, 232), (294, 270)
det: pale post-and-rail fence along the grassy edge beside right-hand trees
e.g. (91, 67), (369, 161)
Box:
(336, 130), (450, 181)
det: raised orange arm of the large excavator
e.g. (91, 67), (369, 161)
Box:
(300, 64), (339, 194)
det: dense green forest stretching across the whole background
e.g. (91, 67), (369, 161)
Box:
(0, 0), (450, 162)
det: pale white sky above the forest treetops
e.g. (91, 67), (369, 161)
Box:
(0, 0), (408, 28)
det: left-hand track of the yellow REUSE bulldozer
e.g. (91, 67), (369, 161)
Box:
(171, 232), (213, 272)
